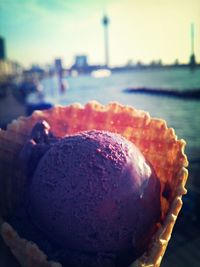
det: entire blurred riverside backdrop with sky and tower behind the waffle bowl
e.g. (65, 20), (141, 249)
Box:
(0, 0), (200, 267)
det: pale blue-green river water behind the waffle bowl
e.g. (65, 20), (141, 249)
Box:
(42, 68), (200, 150)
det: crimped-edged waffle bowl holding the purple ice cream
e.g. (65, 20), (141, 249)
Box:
(0, 101), (188, 267)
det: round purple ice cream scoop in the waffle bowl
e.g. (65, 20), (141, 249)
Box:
(22, 124), (160, 264)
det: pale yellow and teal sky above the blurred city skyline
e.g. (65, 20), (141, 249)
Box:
(0, 0), (200, 66)
